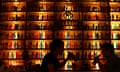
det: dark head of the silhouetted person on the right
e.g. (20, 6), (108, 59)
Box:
(101, 43), (114, 58)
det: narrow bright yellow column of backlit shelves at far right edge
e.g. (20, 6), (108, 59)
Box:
(109, 2), (120, 56)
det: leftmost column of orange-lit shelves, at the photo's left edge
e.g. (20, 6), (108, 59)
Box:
(0, 1), (26, 66)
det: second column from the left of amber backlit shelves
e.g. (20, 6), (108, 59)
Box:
(26, 1), (54, 64)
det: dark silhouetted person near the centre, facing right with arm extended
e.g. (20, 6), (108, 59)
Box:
(41, 39), (72, 72)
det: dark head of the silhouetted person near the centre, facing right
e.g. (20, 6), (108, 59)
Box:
(50, 39), (64, 54)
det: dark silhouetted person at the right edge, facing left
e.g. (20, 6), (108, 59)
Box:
(94, 43), (120, 72)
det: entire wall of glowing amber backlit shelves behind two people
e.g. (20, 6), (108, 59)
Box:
(0, 0), (120, 71)
